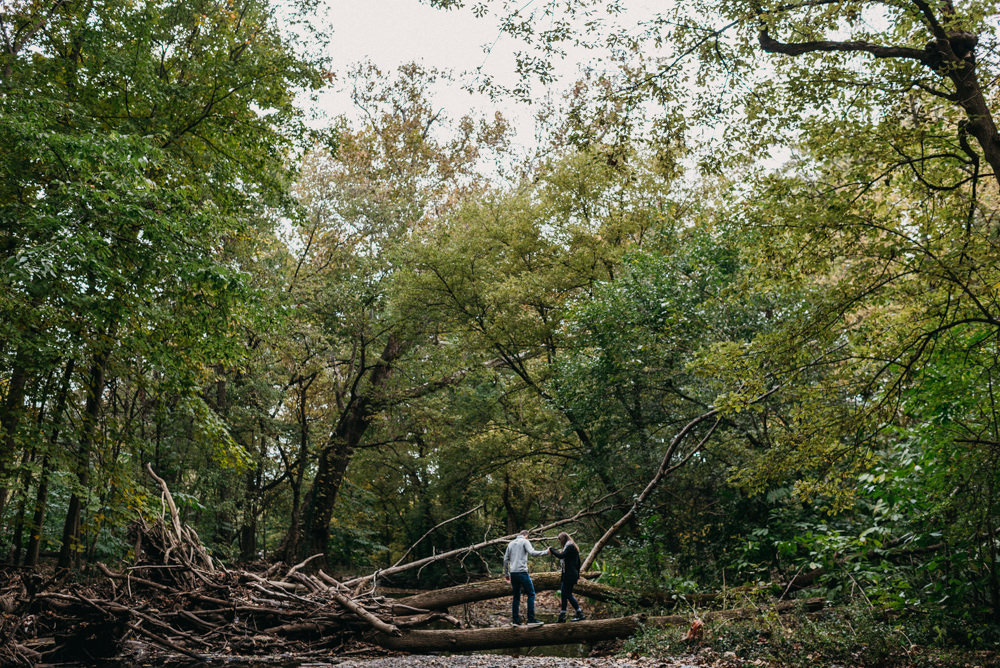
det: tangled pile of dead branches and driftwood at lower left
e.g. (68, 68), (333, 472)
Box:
(0, 521), (458, 665)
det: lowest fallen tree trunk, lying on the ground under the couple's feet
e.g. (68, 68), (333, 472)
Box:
(373, 598), (825, 652)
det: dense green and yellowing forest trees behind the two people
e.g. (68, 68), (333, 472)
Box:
(0, 0), (1000, 648)
